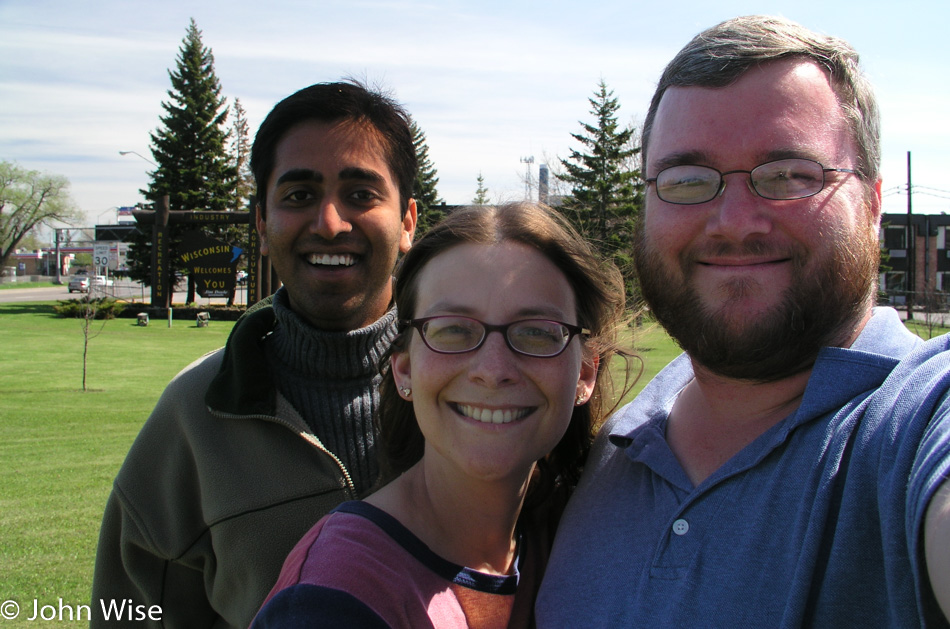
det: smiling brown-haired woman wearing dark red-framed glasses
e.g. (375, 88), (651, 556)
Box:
(254, 204), (624, 628)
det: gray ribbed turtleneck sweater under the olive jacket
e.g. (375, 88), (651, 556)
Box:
(264, 288), (397, 496)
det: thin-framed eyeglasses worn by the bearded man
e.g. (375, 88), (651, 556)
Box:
(646, 158), (857, 205)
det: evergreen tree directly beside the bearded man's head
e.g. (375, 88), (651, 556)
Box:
(559, 80), (643, 298)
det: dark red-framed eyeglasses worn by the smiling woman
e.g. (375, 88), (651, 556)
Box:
(402, 315), (590, 358)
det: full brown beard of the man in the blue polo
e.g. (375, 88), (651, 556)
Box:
(634, 211), (880, 382)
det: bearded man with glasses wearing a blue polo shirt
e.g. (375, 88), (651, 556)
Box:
(537, 17), (950, 628)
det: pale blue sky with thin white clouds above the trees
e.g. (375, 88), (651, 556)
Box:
(0, 0), (950, 224)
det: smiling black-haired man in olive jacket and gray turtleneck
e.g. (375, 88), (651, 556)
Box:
(92, 82), (416, 628)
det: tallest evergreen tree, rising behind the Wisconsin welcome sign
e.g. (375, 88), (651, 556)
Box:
(129, 19), (240, 301)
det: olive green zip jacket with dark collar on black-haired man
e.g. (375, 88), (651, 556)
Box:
(90, 302), (358, 629)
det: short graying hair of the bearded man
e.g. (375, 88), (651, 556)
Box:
(643, 15), (881, 184)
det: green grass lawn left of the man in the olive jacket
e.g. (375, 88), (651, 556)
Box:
(0, 303), (233, 627)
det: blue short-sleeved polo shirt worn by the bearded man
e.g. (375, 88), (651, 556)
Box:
(537, 308), (950, 629)
